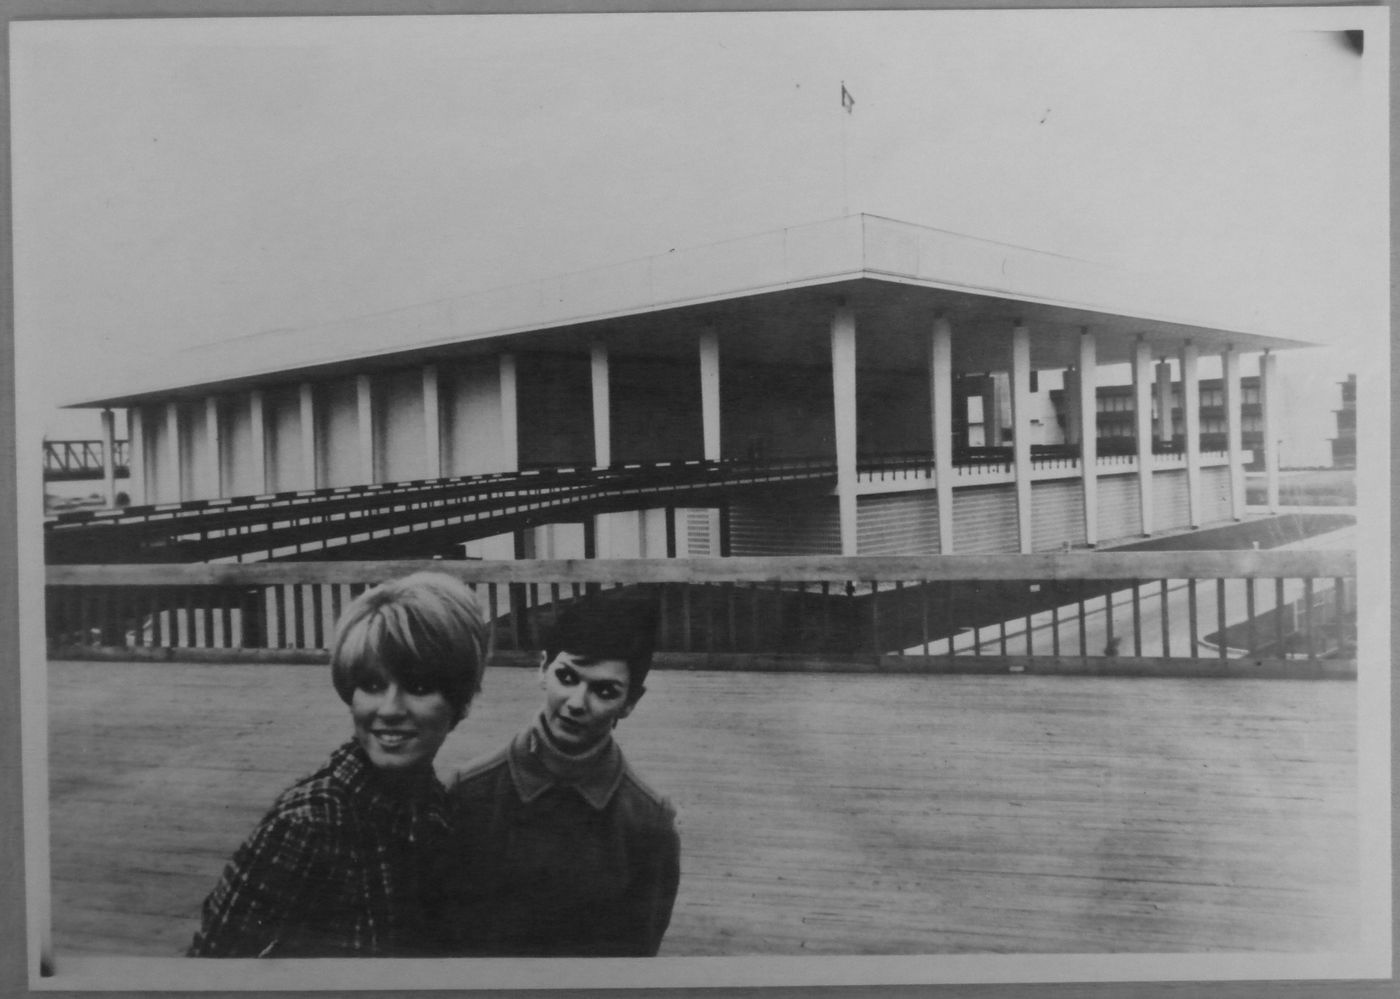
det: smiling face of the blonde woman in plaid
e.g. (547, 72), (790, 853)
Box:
(350, 666), (456, 772)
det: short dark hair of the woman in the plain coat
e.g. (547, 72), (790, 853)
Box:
(545, 590), (661, 701)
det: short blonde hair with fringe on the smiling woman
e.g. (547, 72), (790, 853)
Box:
(330, 572), (490, 721)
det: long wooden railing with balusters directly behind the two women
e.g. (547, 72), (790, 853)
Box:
(48, 550), (1355, 676)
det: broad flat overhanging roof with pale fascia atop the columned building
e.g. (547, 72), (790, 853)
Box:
(64, 215), (1316, 407)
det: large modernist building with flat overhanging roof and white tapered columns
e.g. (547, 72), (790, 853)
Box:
(65, 215), (1288, 557)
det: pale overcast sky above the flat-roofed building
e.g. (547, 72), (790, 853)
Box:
(11, 8), (1389, 461)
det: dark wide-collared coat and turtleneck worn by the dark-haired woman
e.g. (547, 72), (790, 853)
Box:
(441, 716), (680, 957)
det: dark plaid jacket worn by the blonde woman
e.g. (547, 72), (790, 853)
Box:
(189, 742), (447, 957)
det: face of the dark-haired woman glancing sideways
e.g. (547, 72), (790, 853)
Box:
(540, 652), (636, 753)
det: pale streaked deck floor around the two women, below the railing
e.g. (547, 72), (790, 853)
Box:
(49, 662), (1359, 970)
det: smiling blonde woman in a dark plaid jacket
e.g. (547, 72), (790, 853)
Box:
(189, 572), (487, 957)
